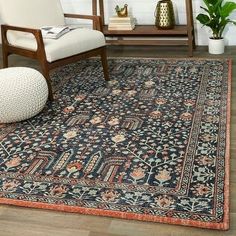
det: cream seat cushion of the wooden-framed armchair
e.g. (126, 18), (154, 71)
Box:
(8, 28), (105, 62)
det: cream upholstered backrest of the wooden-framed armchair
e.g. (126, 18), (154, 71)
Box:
(0, 0), (65, 28)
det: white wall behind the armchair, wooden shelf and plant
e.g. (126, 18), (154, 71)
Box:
(0, 0), (236, 45)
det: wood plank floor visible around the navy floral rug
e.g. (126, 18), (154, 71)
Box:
(0, 46), (236, 236)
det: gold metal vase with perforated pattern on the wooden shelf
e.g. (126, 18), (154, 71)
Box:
(155, 0), (175, 29)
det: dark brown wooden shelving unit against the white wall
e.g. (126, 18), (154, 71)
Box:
(92, 0), (195, 56)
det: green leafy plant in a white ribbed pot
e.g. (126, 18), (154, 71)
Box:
(196, 0), (236, 54)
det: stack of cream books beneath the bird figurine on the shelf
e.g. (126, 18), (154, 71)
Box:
(108, 16), (135, 30)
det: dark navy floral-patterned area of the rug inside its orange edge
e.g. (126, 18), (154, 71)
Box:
(0, 59), (229, 230)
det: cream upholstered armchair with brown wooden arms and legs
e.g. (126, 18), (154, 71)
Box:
(0, 0), (109, 100)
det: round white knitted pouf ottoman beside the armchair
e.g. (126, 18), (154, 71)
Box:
(0, 67), (48, 123)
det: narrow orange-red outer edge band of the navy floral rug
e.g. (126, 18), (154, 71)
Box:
(0, 57), (232, 230)
